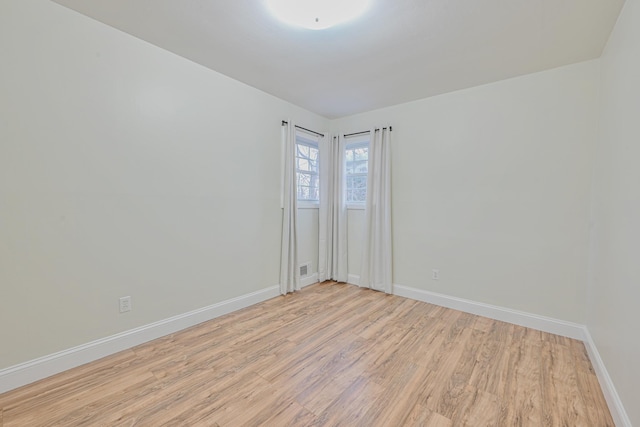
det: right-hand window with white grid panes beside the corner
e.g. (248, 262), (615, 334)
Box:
(345, 135), (369, 204)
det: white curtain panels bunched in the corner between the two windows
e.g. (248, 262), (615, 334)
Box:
(318, 135), (349, 282)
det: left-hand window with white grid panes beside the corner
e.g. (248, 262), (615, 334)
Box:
(296, 135), (320, 203)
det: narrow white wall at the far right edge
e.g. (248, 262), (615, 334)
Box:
(587, 0), (640, 425)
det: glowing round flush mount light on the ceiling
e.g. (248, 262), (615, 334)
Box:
(266, 0), (369, 30)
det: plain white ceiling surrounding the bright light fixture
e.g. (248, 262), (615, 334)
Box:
(54, 0), (624, 118)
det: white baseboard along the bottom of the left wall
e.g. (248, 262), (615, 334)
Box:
(0, 280), (280, 393)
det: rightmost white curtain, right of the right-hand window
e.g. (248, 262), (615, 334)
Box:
(360, 127), (393, 294)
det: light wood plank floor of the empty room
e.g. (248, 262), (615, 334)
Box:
(0, 283), (614, 427)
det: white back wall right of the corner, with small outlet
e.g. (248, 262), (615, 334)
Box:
(332, 60), (599, 323)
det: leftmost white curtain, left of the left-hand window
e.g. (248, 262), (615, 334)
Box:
(280, 120), (300, 295)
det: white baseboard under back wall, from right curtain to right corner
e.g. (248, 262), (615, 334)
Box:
(393, 285), (584, 340)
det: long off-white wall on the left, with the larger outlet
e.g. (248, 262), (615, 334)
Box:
(0, 0), (328, 369)
